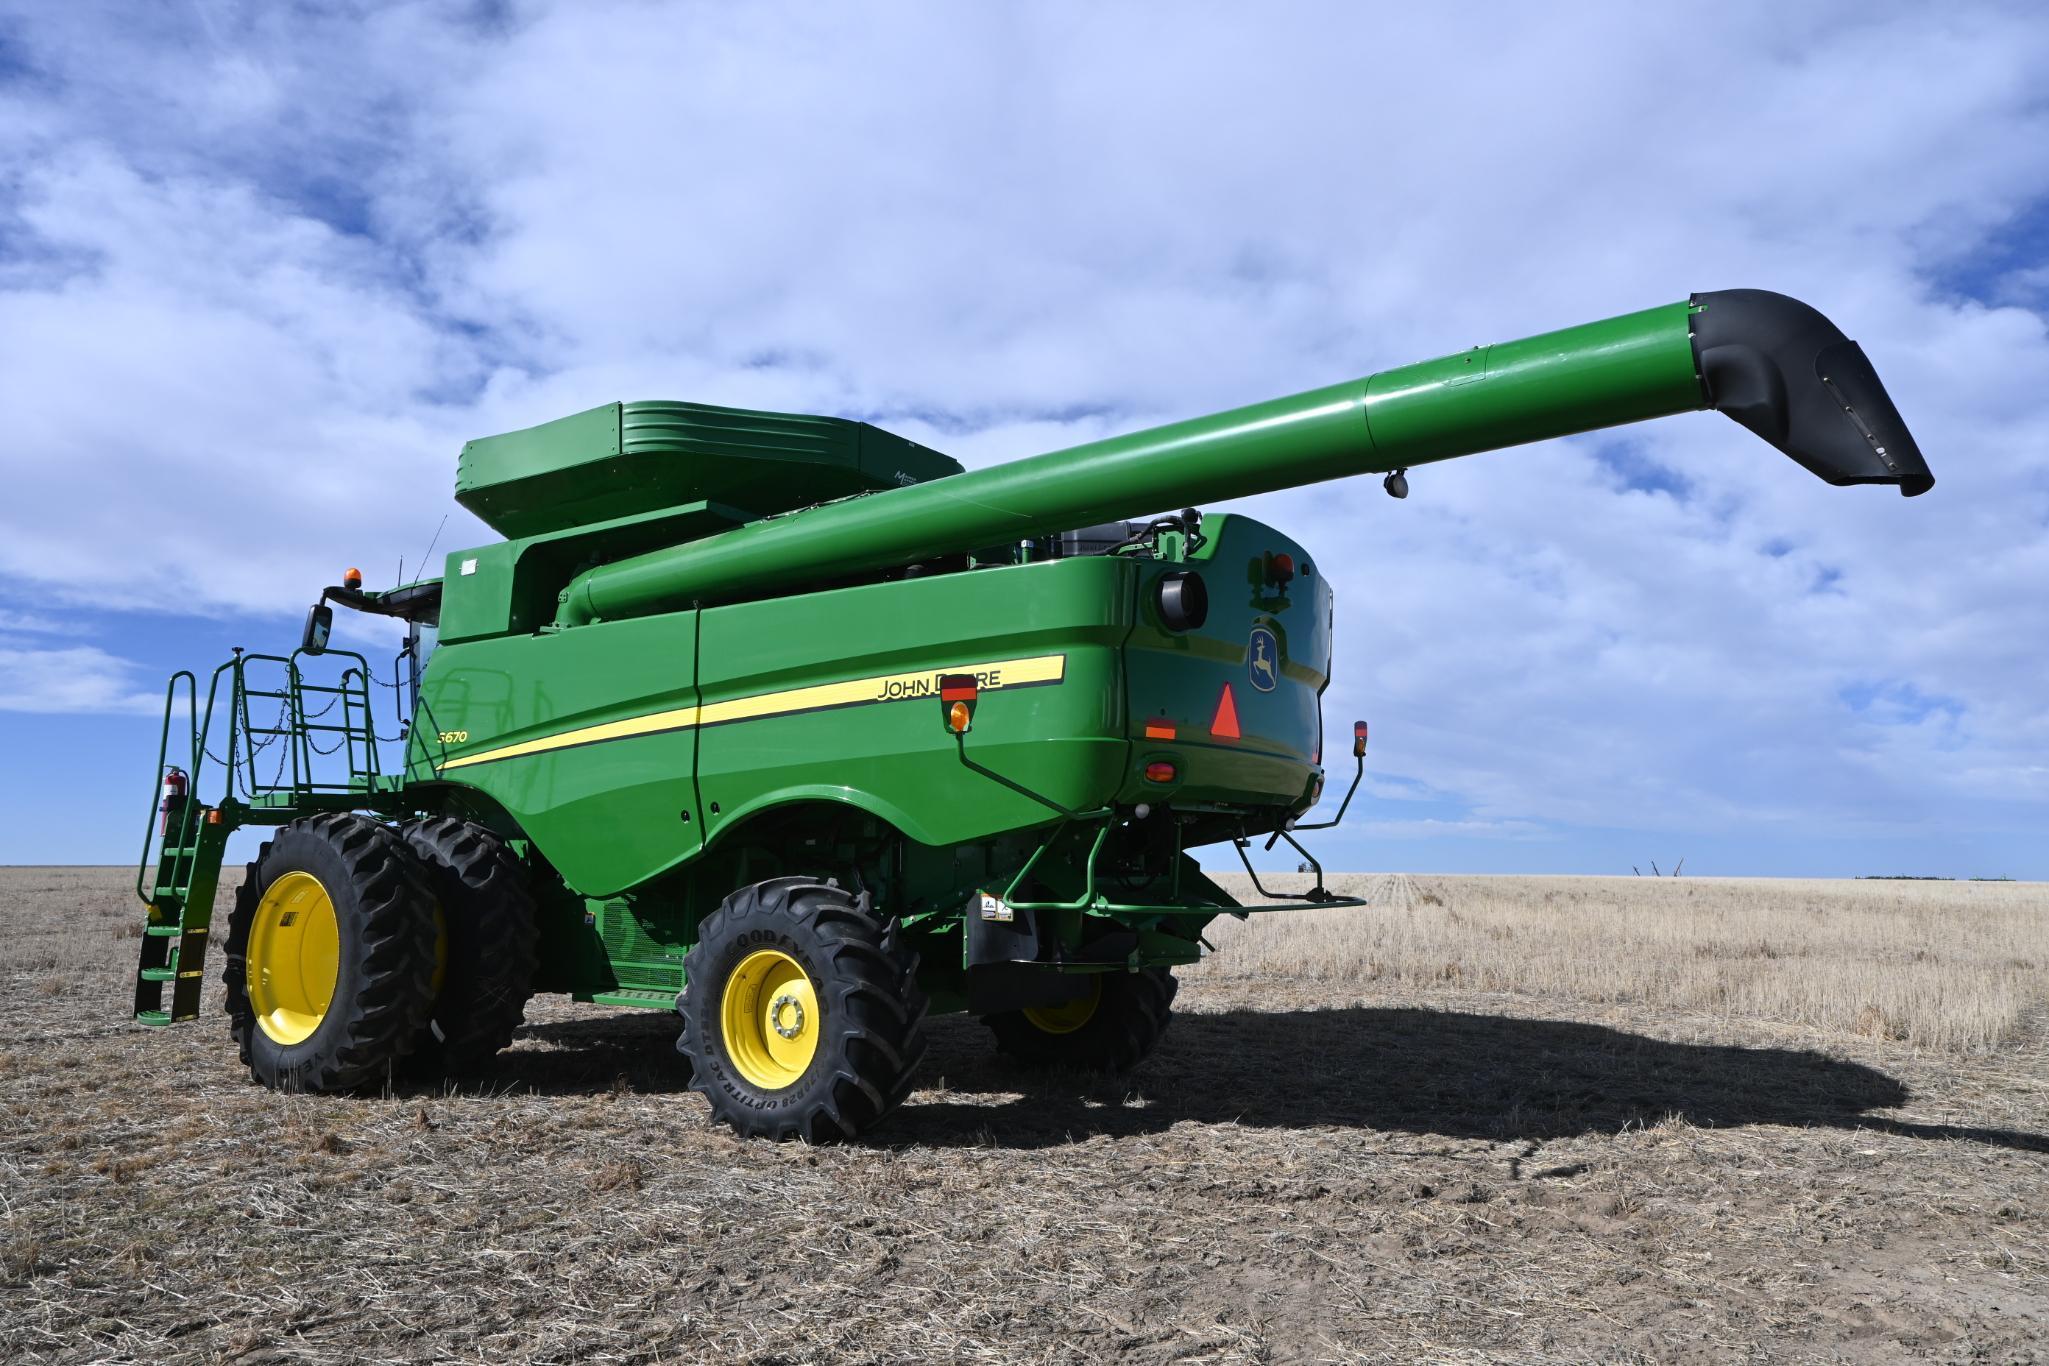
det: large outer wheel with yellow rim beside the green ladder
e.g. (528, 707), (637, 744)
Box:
(221, 813), (436, 1092)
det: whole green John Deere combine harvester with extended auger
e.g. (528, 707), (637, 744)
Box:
(135, 291), (1932, 1141)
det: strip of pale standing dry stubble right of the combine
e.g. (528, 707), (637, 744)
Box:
(1197, 877), (2049, 1051)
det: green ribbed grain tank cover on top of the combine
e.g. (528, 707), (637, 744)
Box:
(455, 401), (961, 537)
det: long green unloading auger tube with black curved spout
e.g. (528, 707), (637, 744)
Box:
(557, 289), (1934, 625)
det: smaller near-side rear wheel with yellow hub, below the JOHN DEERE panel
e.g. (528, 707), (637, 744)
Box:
(676, 877), (926, 1143)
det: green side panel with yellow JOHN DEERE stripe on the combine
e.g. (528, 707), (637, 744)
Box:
(410, 557), (1139, 897)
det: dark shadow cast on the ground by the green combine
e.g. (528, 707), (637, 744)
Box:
(488, 1008), (2049, 1153)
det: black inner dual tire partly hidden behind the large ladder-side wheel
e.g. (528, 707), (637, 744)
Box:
(400, 815), (539, 1077)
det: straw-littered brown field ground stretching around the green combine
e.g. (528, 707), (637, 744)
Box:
(0, 868), (2049, 1362)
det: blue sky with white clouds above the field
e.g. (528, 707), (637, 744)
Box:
(0, 0), (2049, 879)
